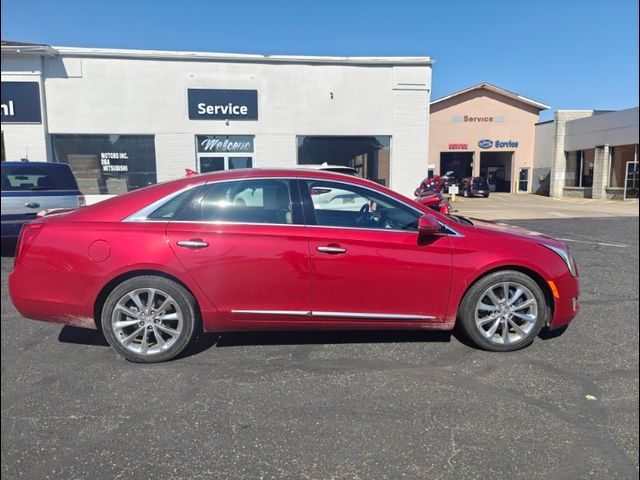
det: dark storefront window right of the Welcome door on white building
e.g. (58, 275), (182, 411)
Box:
(297, 136), (391, 186)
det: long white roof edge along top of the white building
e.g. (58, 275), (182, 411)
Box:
(2, 45), (433, 66)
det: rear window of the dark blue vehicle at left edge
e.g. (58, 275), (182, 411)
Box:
(2, 163), (78, 192)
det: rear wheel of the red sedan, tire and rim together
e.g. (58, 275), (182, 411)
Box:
(101, 275), (196, 363)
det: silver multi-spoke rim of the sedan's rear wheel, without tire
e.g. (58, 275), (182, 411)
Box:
(111, 288), (183, 355)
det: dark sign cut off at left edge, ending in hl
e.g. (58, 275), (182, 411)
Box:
(2, 82), (42, 123)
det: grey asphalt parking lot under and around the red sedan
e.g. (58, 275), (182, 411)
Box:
(2, 213), (639, 480)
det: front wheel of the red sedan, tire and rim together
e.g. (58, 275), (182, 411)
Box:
(458, 270), (550, 352)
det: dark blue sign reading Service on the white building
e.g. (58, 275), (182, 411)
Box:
(187, 88), (258, 120)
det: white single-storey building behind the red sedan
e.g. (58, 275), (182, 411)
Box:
(2, 42), (432, 200)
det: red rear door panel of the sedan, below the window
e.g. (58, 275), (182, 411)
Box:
(166, 222), (310, 321)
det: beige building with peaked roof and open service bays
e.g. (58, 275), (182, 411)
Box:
(428, 83), (549, 192)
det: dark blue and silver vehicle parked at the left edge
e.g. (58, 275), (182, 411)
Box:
(1, 162), (85, 240)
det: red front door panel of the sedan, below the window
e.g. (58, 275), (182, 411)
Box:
(309, 227), (452, 321)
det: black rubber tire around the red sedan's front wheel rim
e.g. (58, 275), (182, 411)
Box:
(458, 270), (551, 352)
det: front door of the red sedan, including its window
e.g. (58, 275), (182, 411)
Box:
(299, 180), (452, 321)
